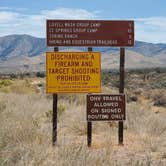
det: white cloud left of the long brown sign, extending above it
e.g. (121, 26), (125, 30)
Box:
(0, 8), (97, 37)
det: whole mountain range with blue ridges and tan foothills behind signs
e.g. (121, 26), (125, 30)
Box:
(0, 35), (166, 72)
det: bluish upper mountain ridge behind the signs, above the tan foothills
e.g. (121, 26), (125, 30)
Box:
(0, 35), (166, 59)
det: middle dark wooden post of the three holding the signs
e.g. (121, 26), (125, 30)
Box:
(87, 47), (93, 147)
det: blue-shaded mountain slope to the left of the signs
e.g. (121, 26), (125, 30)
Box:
(0, 35), (47, 59)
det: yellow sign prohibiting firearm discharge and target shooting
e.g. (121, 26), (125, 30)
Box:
(46, 52), (101, 93)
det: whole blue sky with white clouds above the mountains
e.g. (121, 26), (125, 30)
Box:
(0, 0), (166, 43)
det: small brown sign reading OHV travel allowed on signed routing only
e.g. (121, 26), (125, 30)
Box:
(87, 94), (126, 121)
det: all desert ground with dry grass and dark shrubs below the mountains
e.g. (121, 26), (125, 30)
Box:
(0, 68), (166, 166)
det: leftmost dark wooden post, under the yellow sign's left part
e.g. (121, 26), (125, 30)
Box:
(52, 47), (59, 146)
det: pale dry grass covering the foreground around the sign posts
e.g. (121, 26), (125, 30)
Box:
(0, 76), (166, 166)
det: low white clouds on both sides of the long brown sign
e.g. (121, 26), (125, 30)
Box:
(0, 8), (166, 43)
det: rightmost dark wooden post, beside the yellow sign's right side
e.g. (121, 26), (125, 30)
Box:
(118, 48), (125, 145)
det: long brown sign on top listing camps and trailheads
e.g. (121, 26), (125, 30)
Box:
(46, 20), (134, 47)
